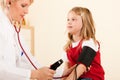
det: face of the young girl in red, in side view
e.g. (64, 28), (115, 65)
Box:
(67, 11), (82, 35)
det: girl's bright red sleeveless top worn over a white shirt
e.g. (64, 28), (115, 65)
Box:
(67, 41), (104, 80)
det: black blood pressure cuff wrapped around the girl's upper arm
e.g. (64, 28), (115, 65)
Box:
(78, 46), (96, 67)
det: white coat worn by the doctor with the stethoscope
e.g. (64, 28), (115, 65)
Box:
(0, 8), (40, 80)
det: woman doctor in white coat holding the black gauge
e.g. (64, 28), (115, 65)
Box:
(0, 0), (55, 80)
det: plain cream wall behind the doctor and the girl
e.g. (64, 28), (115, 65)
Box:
(28, 0), (120, 80)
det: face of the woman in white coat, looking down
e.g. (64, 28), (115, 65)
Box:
(9, 0), (30, 22)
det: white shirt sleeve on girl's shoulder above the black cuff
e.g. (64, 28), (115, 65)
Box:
(82, 38), (99, 51)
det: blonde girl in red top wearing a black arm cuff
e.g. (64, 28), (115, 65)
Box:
(63, 7), (104, 80)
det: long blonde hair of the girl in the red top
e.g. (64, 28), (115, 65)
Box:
(64, 7), (96, 51)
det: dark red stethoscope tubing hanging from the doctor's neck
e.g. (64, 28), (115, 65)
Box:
(14, 25), (69, 79)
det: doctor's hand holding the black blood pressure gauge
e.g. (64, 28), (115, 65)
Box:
(31, 67), (55, 80)
